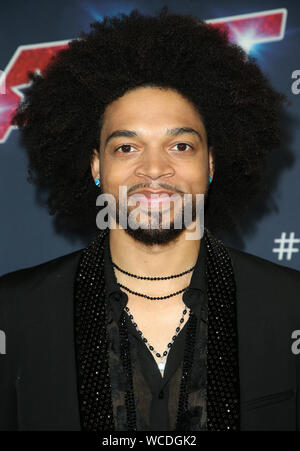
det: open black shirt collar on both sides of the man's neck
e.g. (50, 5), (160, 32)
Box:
(104, 233), (207, 321)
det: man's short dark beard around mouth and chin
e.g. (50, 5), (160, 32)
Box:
(99, 184), (207, 246)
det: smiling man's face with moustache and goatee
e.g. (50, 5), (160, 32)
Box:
(91, 87), (213, 245)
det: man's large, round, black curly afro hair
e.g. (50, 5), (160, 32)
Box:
(12, 6), (287, 237)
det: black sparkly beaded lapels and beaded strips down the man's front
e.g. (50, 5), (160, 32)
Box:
(74, 228), (240, 431)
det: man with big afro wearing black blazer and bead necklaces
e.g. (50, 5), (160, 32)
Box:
(0, 8), (300, 431)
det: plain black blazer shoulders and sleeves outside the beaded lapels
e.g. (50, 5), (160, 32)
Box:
(0, 247), (300, 431)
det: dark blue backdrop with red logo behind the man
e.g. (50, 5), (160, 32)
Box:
(0, 0), (300, 275)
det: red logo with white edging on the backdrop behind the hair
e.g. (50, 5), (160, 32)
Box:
(0, 8), (287, 143)
